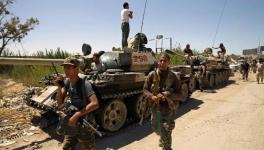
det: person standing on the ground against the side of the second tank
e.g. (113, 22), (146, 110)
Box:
(195, 61), (206, 92)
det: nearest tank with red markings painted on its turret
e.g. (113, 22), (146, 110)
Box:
(0, 33), (194, 132)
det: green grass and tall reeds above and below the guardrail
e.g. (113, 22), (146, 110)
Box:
(0, 48), (70, 86)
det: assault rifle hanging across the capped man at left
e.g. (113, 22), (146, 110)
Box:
(56, 100), (102, 137)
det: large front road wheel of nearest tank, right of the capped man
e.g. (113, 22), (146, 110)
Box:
(100, 99), (127, 132)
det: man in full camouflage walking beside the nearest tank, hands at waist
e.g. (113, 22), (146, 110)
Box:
(143, 53), (182, 150)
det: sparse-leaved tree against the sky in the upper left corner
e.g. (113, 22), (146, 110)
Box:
(0, 0), (39, 56)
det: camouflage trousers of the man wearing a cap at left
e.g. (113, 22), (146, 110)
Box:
(63, 132), (95, 150)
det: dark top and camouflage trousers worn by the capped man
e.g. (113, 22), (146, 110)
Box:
(60, 78), (96, 150)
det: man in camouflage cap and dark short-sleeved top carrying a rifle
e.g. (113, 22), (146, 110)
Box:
(54, 57), (99, 150)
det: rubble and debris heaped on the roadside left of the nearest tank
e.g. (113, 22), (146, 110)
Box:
(0, 87), (41, 147)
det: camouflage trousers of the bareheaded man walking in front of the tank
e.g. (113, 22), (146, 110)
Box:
(152, 112), (175, 150)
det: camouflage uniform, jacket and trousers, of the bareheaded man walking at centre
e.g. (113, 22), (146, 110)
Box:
(144, 69), (183, 150)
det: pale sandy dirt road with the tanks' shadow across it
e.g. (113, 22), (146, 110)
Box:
(0, 74), (264, 150)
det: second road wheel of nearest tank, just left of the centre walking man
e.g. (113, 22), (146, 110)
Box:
(133, 94), (150, 119)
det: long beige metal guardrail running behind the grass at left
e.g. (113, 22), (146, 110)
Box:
(0, 57), (64, 66)
